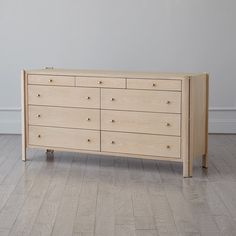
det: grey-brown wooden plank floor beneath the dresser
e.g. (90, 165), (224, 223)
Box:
(0, 135), (236, 236)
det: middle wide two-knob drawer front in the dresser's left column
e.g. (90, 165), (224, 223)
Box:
(29, 105), (100, 130)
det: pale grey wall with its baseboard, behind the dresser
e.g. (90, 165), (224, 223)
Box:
(0, 0), (236, 133)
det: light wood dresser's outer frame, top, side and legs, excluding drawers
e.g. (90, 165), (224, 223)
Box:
(21, 69), (209, 177)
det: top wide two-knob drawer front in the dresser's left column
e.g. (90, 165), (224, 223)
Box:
(28, 85), (100, 108)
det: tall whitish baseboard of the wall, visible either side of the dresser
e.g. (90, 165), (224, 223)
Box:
(0, 107), (236, 134)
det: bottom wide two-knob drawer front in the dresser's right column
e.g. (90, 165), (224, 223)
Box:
(101, 131), (180, 158)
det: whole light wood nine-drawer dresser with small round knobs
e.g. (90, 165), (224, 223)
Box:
(22, 69), (209, 177)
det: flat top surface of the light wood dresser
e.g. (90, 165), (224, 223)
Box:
(26, 69), (206, 79)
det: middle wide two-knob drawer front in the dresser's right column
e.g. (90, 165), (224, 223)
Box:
(101, 110), (180, 136)
